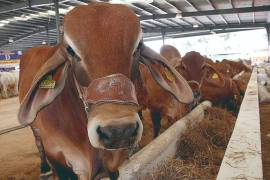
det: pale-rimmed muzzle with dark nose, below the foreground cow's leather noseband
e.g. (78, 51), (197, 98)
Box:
(87, 110), (143, 150)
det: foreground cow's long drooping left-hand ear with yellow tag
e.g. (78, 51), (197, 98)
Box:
(18, 49), (70, 125)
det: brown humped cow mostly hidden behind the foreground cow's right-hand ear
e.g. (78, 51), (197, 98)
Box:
(135, 45), (191, 137)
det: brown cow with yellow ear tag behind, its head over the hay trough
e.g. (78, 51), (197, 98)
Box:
(179, 51), (240, 109)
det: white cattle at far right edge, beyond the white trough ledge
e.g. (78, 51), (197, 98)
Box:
(257, 63), (270, 103)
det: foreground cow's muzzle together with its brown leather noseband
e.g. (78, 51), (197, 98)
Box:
(85, 74), (143, 150)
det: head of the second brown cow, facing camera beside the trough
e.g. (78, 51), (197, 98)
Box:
(179, 51), (225, 98)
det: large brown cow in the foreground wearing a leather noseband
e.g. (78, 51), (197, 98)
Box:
(18, 3), (192, 180)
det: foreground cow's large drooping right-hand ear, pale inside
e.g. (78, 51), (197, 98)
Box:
(139, 44), (194, 103)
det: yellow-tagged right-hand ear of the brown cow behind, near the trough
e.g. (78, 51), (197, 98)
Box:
(205, 64), (225, 87)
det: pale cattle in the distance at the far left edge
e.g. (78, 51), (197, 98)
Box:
(0, 70), (19, 99)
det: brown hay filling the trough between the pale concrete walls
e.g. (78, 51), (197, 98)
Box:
(142, 107), (236, 180)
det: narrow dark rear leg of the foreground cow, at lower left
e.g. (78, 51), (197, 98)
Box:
(31, 126), (53, 180)
